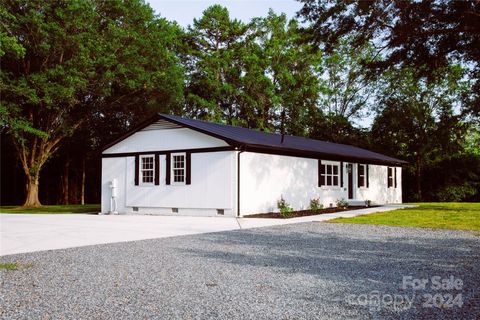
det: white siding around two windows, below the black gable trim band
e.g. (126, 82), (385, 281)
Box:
(102, 151), (236, 215)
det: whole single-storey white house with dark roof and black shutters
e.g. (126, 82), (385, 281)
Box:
(102, 114), (405, 216)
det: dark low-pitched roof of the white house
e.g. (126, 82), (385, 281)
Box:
(101, 114), (407, 165)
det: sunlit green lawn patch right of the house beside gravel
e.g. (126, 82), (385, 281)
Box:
(329, 202), (480, 231)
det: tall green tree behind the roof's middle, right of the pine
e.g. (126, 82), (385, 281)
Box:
(248, 10), (321, 136)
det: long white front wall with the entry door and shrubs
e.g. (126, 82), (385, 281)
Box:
(240, 152), (402, 215)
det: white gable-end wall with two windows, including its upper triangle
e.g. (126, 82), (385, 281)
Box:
(102, 128), (237, 216)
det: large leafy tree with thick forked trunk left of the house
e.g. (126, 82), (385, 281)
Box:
(0, 0), (182, 207)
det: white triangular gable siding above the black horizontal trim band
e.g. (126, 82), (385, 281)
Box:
(103, 128), (228, 153)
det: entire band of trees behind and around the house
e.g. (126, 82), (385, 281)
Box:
(0, 0), (480, 206)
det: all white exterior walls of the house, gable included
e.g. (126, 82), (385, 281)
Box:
(102, 124), (402, 216)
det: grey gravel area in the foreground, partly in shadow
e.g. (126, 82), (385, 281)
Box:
(0, 223), (480, 319)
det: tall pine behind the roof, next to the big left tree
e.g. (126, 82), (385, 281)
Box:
(185, 5), (247, 124)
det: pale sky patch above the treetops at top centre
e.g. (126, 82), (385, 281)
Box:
(146, 0), (301, 27)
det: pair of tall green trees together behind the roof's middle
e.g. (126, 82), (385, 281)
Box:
(185, 5), (320, 135)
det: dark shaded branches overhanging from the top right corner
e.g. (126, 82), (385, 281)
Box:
(298, 0), (480, 115)
